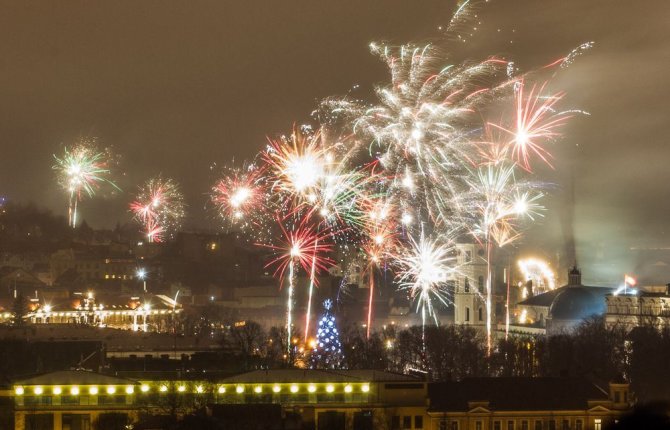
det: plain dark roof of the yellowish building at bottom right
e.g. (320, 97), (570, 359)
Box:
(428, 378), (608, 412)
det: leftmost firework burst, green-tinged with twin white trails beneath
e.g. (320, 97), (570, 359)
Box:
(53, 138), (119, 228)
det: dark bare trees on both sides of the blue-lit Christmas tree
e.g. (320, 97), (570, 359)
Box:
(215, 318), (670, 402)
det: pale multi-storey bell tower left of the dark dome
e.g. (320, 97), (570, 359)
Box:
(454, 243), (496, 329)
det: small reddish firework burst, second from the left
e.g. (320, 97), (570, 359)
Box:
(130, 176), (185, 242)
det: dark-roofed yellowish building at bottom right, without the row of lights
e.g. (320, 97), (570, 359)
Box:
(428, 378), (630, 430)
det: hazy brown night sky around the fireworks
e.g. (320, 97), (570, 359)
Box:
(0, 0), (670, 282)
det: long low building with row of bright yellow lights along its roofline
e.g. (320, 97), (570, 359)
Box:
(7, 369), (429, 430)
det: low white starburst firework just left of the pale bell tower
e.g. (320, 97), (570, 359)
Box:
(396, 233), (456, 350)
